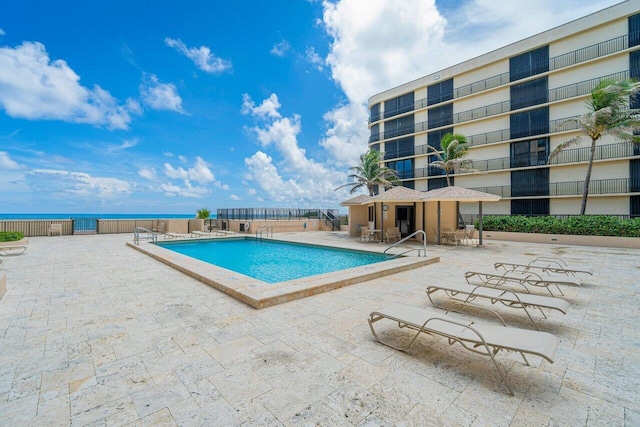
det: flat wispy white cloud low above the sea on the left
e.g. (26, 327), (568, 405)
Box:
(26, 169), (133, 200)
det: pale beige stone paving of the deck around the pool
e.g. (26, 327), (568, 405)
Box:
(0, 232), (640, 426)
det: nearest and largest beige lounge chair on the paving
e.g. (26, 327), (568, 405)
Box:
(368, 304), (560, 396)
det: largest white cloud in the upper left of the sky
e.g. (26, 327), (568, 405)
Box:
(0, 42), (140, 129)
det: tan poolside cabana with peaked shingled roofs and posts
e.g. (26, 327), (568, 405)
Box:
(341, 186), (500, 245)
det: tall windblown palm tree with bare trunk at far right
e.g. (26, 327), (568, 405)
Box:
(547, 79), (640, 215)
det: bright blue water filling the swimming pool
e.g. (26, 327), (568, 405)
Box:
(158, 238), (386, 283)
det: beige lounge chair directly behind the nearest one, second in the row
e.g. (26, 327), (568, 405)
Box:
(427, 283), (569, 329)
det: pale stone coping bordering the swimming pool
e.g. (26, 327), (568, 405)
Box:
(127, 237), (440, 309)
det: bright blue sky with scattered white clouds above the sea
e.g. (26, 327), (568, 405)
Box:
(0, 0), (618, 214)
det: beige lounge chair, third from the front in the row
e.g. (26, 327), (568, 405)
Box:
(464, 271), (580, 296)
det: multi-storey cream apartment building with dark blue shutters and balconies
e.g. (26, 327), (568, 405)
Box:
(369, 0), (640, 217)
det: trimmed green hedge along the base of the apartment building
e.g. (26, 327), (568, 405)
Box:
(476, 215), (640, 237)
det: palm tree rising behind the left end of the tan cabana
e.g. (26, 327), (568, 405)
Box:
(336, 150), (398, 196)
